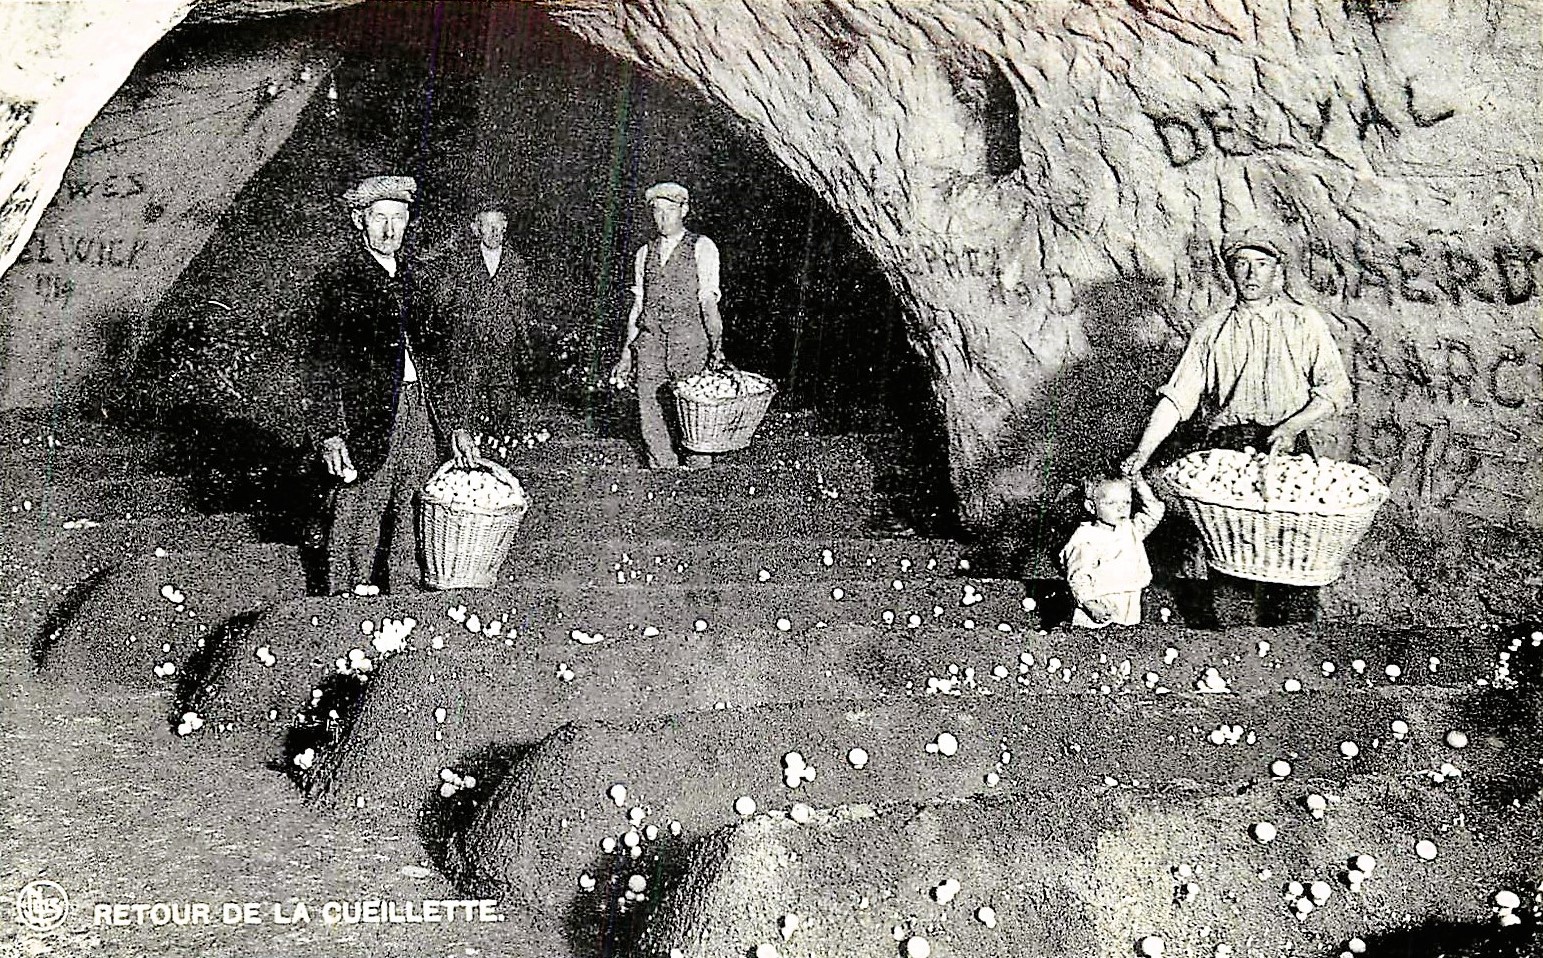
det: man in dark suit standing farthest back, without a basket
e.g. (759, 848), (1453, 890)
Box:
(441, 194), (534, 432)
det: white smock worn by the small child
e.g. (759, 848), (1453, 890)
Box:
(1060, 500), (1163, 628)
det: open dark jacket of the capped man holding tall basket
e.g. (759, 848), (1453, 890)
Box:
(306, 242), (469, 477)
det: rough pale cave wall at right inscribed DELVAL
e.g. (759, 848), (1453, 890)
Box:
(555, 0), (1543, 526)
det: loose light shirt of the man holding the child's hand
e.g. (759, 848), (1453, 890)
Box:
(1157, 296), (1350, 430)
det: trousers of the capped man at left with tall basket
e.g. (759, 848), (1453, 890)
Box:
(327, 383), (440, 594)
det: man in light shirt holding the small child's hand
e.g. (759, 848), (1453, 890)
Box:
(1123, 227), (1350, 626)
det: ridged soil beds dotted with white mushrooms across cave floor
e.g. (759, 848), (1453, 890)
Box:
(6, 404), (1543, 958)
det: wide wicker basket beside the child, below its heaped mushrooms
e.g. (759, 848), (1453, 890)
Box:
(1160, 453), (1387, 586)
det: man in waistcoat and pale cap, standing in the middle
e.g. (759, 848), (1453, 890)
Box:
(611, 182), (724, 469)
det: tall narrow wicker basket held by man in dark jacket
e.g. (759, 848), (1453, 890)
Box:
(418, 461), (526, 589)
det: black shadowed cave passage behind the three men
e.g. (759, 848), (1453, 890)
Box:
(123, 3), (954, 538)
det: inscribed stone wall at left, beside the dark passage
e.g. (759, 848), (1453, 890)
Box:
(0, 22), (324, 407)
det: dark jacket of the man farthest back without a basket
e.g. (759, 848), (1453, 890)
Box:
(441, 242), (531, 386)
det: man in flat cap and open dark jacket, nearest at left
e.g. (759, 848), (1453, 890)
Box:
(297, 176), (477, 594)
